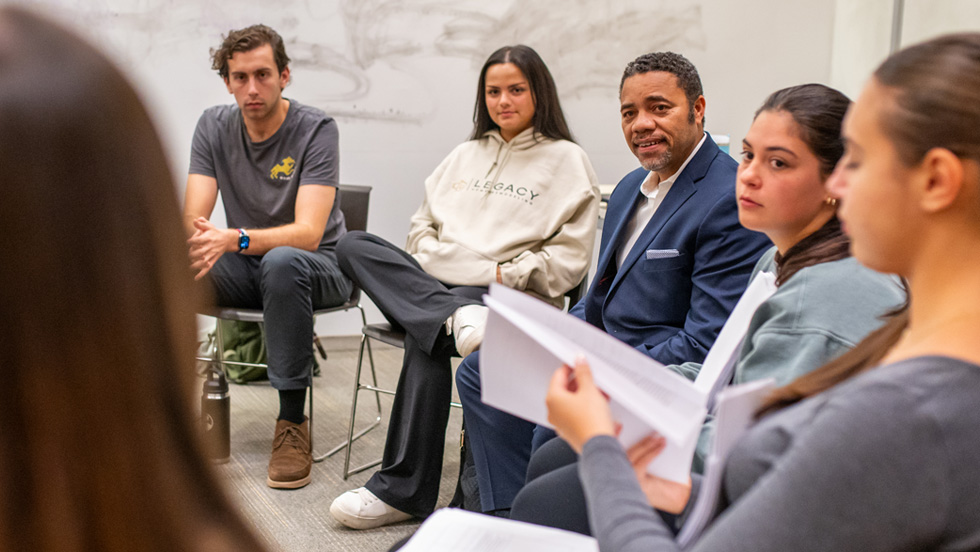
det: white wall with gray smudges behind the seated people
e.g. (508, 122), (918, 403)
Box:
(11, 0), (844, 334)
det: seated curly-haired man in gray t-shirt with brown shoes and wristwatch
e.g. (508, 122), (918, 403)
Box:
(184, 25), (351, 489)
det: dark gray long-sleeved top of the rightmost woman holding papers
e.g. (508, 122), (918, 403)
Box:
(579, 357), (980, 552)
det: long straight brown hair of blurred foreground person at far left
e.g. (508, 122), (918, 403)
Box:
(0, 8), (262, 552)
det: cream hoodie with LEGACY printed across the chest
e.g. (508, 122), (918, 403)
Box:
(405, 128), (599, 306)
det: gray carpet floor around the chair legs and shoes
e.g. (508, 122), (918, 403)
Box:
(211, 337), (462, 551)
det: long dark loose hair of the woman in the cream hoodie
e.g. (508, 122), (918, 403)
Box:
(470, 44), (575, 142)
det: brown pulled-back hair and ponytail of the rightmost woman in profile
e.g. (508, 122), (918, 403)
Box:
(759, 33), (980, 415)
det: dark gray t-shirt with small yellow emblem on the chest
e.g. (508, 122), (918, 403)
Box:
(189, 100), (347, 249)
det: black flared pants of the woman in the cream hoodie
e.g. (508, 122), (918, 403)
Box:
(337, 232), (487, 517)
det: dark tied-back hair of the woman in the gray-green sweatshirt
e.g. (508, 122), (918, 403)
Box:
(755, 84), (851, 285)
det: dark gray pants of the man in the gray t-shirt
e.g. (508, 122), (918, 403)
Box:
(208, 247), (352, 390)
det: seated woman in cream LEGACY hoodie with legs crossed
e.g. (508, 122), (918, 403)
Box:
(330, 45), (599, 529)
